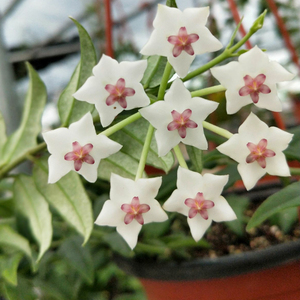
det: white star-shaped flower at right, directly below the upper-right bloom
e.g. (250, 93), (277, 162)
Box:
(217, 113), (293, 190)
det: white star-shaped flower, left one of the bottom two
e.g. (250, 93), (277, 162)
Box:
(95, 174), (168, 249)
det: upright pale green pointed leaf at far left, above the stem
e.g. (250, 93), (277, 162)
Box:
(0, 63), (47, 164)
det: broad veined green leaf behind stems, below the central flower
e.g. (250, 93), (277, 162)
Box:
(98, 119), (174, 180)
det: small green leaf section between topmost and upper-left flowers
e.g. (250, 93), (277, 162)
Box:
(141, 55), (174, 89)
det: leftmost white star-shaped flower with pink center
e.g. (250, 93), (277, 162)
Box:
(43, 113), (122, 183)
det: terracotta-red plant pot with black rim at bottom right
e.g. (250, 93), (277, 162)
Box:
(117, 240), (300, 300)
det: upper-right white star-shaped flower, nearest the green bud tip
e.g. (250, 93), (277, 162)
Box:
(211, 46), (294, 114)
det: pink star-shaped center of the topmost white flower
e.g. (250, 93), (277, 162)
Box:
(168, 27), (199, 57)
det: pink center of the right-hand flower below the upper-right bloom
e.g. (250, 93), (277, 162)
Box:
(246, 139), (276, 169)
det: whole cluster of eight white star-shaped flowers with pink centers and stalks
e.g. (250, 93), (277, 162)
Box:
(43, 5), (293, 249)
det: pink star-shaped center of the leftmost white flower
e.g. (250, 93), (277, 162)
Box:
(64, 142), (95, 171)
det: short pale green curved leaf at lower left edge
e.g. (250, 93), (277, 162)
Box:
(0, 224), (32, 259)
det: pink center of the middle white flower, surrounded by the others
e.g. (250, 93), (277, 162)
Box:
(167, 109), (198, 139)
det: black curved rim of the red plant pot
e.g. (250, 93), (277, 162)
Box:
(115, 239), (300, 281)
